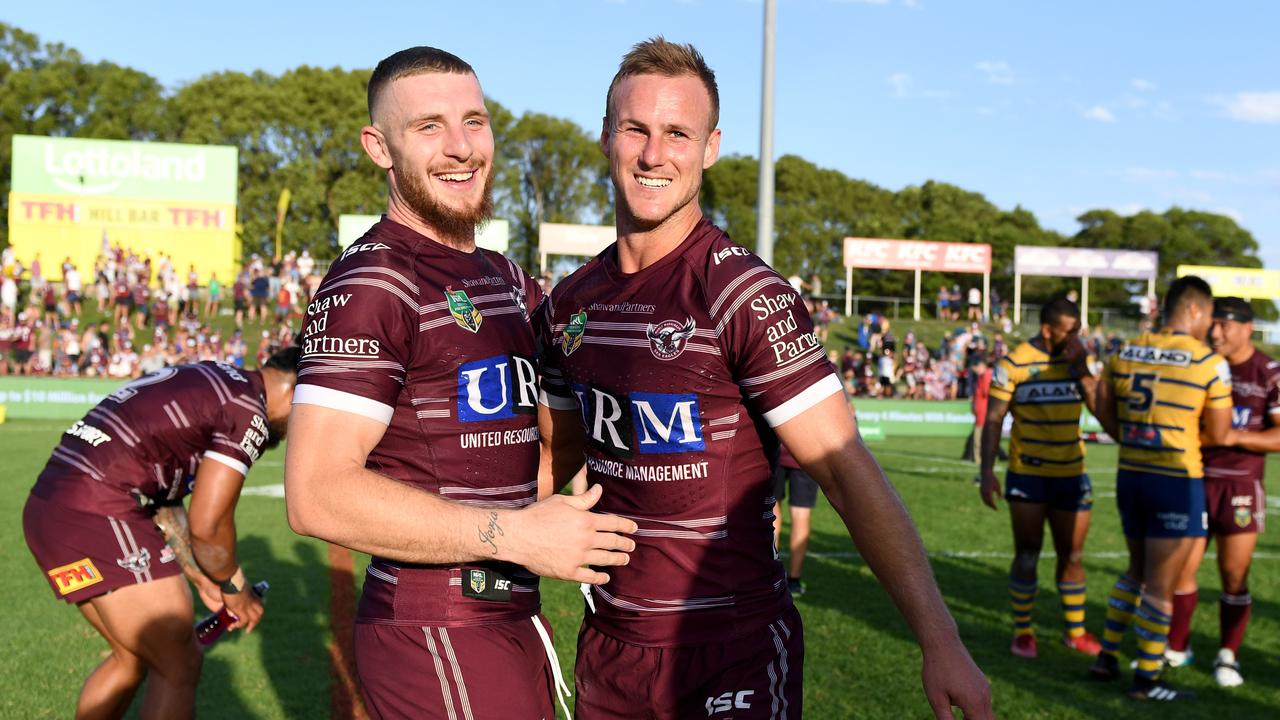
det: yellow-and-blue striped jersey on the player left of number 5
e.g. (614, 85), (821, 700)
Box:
(991, 342), (1084, 478)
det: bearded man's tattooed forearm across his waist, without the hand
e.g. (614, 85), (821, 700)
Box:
(285, 458), (515, 564)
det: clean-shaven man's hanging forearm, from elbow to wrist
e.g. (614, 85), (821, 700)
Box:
(824, 441), (956, 650)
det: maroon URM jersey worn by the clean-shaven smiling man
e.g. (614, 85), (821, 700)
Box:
(539, 219), (842, 646)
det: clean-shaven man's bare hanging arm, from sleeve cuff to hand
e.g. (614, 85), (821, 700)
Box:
(776, 392), (992, 719)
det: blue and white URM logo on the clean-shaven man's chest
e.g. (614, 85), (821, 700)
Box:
(573, 384), (707, 457)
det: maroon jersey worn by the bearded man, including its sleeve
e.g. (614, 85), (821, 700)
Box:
(293, 217), (541, 625)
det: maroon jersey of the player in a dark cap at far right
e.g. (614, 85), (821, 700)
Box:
(1204, 350), (1280, 483)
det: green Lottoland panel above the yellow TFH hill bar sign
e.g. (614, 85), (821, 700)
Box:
(12, 135), (237, 204)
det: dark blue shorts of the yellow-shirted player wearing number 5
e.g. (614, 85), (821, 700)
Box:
(1116, 470), (1208, 538)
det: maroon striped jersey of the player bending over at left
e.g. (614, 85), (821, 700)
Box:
(31, 363), (269, 518)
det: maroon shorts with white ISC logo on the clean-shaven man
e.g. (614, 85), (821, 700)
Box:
(573, 607), (804, 720)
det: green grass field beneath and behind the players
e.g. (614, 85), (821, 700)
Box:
(0, 421), (1280, 719)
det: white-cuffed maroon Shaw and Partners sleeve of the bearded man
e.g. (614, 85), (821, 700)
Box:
(293, 236), (419, 424)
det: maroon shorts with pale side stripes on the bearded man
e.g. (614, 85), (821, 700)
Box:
(356, 614), (556, 720)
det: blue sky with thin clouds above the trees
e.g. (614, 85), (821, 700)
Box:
(0, 0), (1280, 269)
